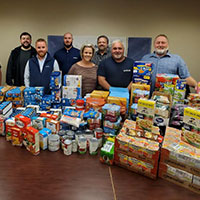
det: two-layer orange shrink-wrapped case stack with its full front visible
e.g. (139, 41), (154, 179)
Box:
(114, 117), (162, 179)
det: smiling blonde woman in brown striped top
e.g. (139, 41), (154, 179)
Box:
(68, 44), (98, 97)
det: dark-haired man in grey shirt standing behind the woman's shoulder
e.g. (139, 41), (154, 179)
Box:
(92, 35), (111, 65)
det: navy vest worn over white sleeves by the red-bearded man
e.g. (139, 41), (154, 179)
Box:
(29, 53), (55, 94)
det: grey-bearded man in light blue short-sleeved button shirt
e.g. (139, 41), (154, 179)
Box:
(141, 34), (197, 92)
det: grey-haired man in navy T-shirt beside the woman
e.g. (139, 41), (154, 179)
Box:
(97, 40), (134, 90)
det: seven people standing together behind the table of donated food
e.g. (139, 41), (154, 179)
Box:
(2, 32), (197, 96)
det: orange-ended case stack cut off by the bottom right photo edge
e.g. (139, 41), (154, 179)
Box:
(159, 127), (200, 194)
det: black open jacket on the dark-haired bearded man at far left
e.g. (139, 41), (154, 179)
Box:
(6, 46), (37, 86)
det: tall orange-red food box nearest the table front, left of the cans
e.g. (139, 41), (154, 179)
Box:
(23, 126), (40, 155)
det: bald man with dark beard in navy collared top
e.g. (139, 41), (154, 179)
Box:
(54, 32), (81, 76)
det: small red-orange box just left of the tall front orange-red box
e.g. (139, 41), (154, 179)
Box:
(11, 127), (23, 146)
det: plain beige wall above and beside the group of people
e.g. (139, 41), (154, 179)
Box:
(0, 0), (200, 83)
